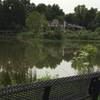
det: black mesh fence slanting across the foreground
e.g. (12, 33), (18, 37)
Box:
(0, 73), (100, 100)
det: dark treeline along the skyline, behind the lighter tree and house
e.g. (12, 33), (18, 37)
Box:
(0, 0), (100, 31)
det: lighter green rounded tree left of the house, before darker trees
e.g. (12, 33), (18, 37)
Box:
(26, 11), (46, 32)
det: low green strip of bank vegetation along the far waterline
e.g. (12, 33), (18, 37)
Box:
(17, 28), (100, 40)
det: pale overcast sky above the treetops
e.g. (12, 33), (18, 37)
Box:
(31, 0), (100, 13)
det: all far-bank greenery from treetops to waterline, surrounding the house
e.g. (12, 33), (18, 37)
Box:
(0, 0), (100, 40)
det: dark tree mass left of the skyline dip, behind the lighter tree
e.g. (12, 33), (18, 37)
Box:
(0, 0), (64, 30)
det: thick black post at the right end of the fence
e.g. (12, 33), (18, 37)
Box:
(89, 77), (100, 100)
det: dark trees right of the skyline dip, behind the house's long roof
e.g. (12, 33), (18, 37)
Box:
(65, 5), (100, 31)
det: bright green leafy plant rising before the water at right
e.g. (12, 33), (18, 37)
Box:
(72, 44), (98, 73)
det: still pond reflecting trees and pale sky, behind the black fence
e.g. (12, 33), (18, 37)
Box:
(0, 40), (100, 88)
